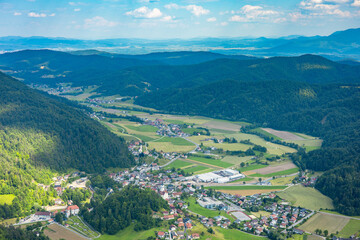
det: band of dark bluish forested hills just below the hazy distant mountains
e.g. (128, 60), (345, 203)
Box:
(0, 50), (360, 96)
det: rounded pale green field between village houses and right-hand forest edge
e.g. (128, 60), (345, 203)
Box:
(277, 185), (334, 210)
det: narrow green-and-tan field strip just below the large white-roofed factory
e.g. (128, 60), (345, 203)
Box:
(206, 185), (286, 196)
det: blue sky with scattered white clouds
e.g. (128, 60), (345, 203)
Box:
(0, 0), (360, 39)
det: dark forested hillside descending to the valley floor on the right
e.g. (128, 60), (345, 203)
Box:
(136, 81), (360, 215)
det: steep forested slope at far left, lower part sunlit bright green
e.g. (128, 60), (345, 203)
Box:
(0, 73), (133, 218)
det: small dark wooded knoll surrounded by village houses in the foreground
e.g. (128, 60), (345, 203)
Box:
(83, 187), (169, 234)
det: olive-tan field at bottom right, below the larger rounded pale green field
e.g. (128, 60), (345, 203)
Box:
(299, 213), (349, 234)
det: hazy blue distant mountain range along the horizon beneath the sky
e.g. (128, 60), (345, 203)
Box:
(0, 28), (360, 60)
